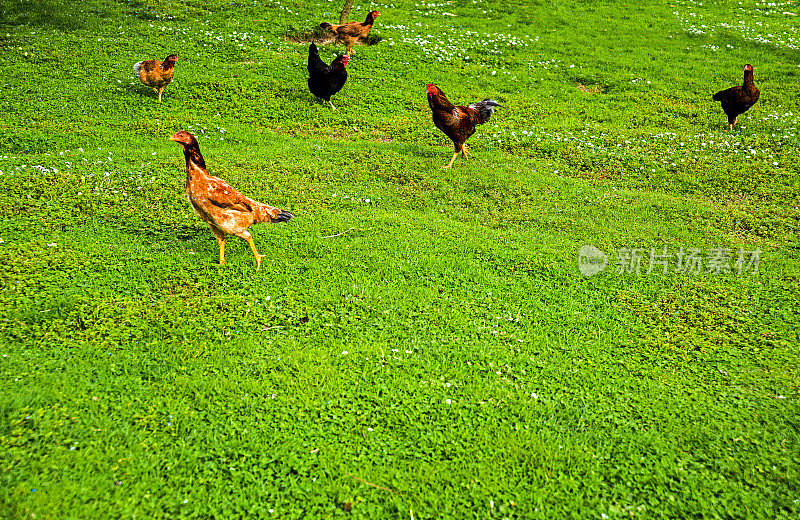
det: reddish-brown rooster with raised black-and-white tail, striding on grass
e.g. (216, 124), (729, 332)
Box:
(428, 83), (502, 168)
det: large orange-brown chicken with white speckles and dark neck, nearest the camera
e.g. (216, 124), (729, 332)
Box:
(169, 130), (294, 269)
